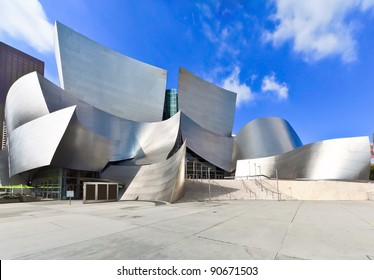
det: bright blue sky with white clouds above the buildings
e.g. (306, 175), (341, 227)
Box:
(0, 0), (374, 144)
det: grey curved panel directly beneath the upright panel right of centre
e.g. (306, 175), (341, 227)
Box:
(181, 113), (233, 171)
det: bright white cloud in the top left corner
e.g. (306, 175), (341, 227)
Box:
(0, 0), (54, 53)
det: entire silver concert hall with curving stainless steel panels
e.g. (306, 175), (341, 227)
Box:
(1, 22), (370, 202)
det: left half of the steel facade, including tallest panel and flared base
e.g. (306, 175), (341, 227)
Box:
(1, 23), (185, 201)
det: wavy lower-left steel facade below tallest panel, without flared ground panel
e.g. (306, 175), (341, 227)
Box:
(6, 72), (180, 175)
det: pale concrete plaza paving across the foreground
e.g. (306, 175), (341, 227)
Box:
(0, 200), (374, 260)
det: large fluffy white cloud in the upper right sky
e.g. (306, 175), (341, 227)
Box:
(265, 0), (374, 62)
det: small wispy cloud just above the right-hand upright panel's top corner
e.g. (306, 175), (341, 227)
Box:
(221, 66), (254, 107)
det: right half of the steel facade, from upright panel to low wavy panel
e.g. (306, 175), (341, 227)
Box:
(179, 68), (370, 180)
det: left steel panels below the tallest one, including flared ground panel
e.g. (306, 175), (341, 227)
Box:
(4, 68), (185, 202)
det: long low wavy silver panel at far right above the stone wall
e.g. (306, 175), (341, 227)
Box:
(235, 137), (370, 180)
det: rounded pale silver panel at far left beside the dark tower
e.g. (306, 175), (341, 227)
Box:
(5, 72), (49, 133)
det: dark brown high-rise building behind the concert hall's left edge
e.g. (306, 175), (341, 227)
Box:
(0, 42), (44, 150)
